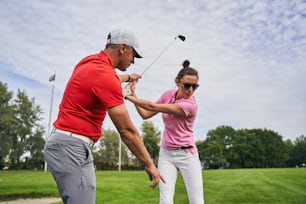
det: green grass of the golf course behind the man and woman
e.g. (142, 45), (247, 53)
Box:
(0, 168), (306, 204)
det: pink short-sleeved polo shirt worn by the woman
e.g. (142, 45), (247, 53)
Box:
(158, 90), (198, 153)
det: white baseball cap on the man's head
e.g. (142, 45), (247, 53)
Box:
(106, 29), (142, 58)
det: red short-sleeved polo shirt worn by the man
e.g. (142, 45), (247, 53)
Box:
(53, 51), (124, 142)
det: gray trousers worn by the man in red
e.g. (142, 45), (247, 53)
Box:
(44, 132), (96, 204)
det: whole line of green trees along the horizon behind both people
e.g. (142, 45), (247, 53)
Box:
(0, 82), (306, 170)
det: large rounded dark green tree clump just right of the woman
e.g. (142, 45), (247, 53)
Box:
(203, 126), (289, 168)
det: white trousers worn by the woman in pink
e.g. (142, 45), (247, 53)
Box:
(158, 147), (204, 204)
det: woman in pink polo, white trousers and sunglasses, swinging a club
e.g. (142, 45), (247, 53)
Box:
(125, 60), (204, 204)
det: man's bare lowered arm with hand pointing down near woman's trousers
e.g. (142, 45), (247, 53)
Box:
(107, 104), (165, 188)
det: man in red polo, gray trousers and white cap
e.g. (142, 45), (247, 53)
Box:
(45, 29), (164, 204)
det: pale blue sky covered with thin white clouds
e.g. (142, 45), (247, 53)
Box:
(0, 0), (306, 140)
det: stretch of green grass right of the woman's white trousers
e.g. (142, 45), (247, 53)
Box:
(204, 169), (306, 204)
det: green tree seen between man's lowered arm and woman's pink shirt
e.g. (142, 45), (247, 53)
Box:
(141, 121), (161, 164)
